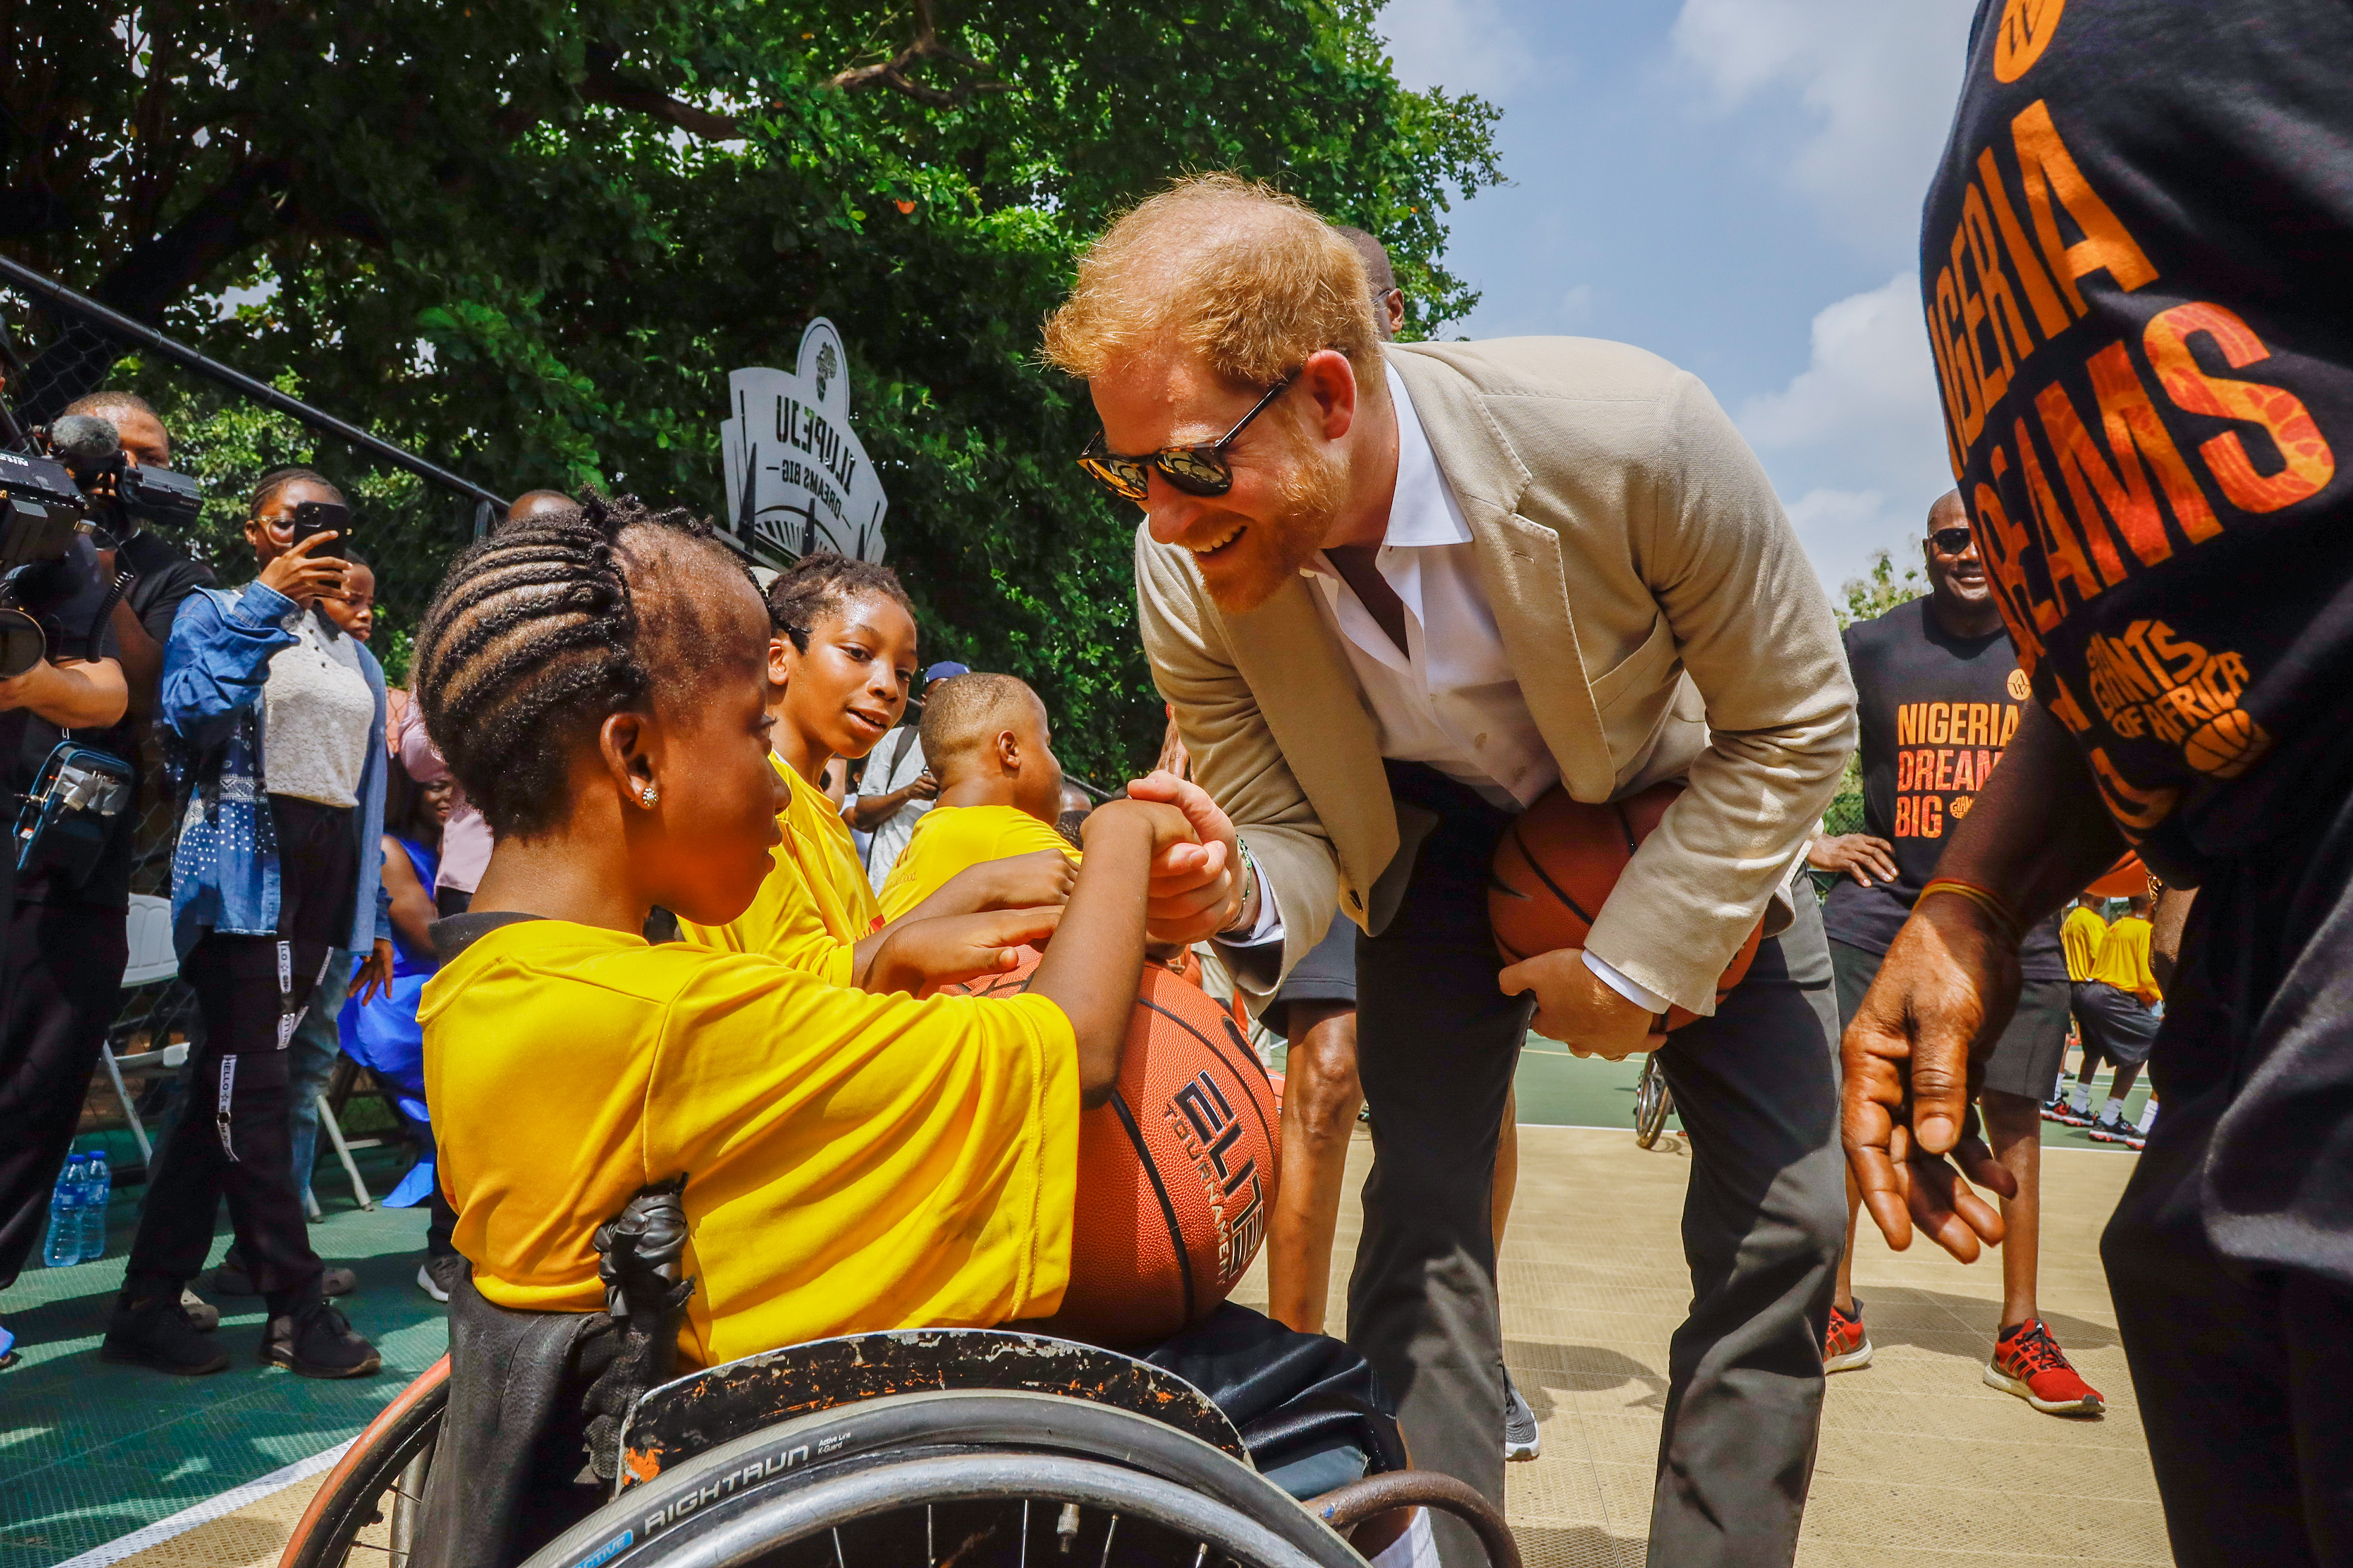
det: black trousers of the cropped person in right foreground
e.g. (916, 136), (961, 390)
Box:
(2099, 802), (2353, 1568)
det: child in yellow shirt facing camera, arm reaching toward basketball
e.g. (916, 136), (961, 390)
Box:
(678, 553), (1071, 985)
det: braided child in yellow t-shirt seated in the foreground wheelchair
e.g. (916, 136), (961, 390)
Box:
(416, 498), (1193, 1366)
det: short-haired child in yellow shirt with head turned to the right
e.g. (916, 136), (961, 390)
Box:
(880, 674), (1078, 919)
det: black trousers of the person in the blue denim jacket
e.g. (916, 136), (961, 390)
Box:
(130, 931), (327, 1312)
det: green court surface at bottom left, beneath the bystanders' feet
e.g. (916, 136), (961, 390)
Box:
(0, 1140), (447, 1568)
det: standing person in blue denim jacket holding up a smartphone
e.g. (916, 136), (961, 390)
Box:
(99, 468), (393, 1377)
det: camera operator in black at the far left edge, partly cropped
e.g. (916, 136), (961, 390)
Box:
(0, 474), (130, 1366)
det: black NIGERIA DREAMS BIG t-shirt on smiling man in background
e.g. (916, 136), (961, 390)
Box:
(1821, 600), (2066, 980)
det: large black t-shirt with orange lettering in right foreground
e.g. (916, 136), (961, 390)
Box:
(1920, 0), (2353, 884)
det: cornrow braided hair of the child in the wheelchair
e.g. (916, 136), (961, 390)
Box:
(414, 493), (748, 839)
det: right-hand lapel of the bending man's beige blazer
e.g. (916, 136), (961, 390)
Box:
(1390, 348), (1616, 802)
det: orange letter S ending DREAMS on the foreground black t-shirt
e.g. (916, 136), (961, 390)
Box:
(2141, 301), (2336, 513)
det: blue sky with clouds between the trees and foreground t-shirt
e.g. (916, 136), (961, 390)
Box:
(1379, 0), (1974, 588)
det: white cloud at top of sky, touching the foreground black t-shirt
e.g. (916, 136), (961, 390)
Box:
(1673, 0), (1977, 256)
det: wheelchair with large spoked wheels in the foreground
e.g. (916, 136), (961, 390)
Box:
(280, 1204), (1520, 1568)
